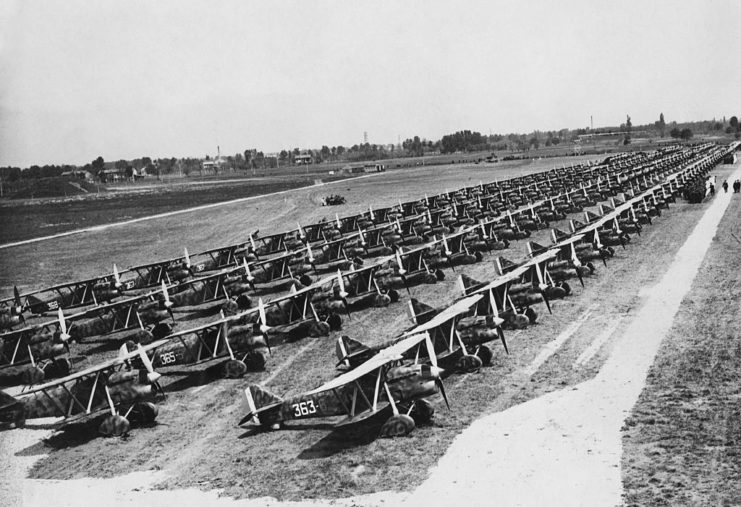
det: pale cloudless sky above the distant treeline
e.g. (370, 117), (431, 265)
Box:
(0, 0), (741, 167)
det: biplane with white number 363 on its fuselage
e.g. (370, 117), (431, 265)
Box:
(239, 333), (447, 437)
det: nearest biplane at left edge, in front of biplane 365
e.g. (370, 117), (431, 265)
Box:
(0, 342), (164, 436)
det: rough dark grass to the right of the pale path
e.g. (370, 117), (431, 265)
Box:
(622, 178), (741, 505)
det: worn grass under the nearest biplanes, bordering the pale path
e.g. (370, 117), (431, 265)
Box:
(18, 163), (728, 499)
